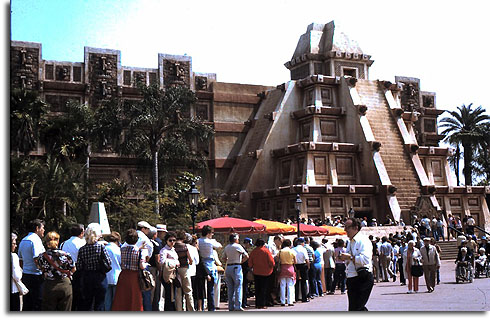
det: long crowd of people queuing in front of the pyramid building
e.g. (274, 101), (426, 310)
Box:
(10, 218), (490, 311)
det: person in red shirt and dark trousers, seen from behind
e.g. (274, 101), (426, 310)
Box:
(248, 238), (274, 309)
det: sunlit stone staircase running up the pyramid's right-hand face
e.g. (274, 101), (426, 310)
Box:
(356, 80), (421, 211)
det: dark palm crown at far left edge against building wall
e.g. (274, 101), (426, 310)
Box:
(10, 89), (48, 156)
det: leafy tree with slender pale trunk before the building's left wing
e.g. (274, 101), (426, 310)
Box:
(122, 84), (213, 216)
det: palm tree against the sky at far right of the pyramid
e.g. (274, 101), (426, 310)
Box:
(440, 103), (490, 185)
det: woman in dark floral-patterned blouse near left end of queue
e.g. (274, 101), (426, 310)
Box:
(38, 232), (75, 311)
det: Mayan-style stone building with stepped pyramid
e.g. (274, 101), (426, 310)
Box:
(11, 21), (490, 230)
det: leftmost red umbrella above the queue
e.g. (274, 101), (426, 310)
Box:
(196, 216), (265, 234)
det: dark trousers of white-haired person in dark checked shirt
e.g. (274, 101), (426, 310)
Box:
(78, 271), (106, 311)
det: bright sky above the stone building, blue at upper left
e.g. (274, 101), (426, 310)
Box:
(11, 0), (490, 115)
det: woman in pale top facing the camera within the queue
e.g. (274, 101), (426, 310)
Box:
(160, 232), (181, 311)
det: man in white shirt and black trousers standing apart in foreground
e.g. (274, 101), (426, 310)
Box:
(341, 218), (374, 311)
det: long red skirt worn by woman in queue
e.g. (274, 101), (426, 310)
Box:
(112, 270), (143, 311)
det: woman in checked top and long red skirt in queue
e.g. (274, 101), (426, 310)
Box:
(112, 229), (145, 311)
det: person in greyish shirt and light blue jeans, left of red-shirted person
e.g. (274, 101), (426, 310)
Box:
(223, 234), (248, 311)
